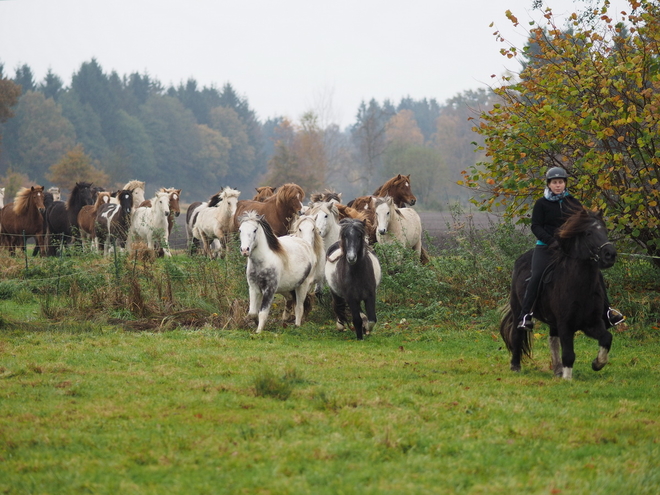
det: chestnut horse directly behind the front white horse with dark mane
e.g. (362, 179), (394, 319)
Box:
(234, 184), (305, 236)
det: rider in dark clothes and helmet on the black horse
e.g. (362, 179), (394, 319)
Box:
(518, 167), (625, 331)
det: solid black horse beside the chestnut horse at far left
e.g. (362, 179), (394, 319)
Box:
(46, 182), (94, 256)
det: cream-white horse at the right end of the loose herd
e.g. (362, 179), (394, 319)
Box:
(375, 196), (422, 258)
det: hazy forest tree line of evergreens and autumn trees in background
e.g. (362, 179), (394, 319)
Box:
(0, 59), (491, 209)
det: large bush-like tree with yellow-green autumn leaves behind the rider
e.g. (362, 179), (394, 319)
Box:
(464, 0), (660, 266)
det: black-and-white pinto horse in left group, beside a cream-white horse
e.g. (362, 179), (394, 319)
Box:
(94, 189), (133, 256)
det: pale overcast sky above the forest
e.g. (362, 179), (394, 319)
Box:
(0, 0), (627, 127)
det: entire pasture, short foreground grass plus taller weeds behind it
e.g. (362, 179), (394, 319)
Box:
(0, 218), (660, 494)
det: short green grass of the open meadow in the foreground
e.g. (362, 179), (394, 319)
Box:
(0, 323), (660, 494)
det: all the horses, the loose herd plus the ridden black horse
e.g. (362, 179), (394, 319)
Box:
(0, 174), (616, 379)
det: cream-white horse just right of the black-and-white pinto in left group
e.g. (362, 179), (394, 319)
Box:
(128, 191), (172, 258)
